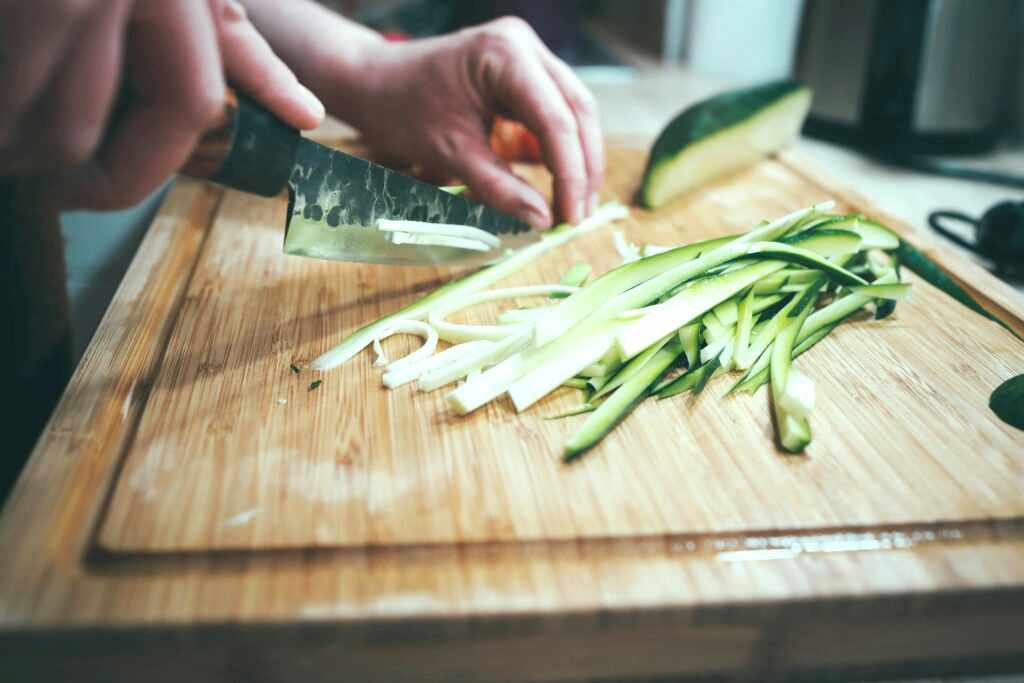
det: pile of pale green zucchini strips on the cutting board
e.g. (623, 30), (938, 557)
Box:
(310, 202), (909, 461)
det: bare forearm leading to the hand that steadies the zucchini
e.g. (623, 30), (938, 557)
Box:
(244, 0), (388, 127)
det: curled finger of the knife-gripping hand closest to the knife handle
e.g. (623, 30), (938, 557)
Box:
(52, 0), (225, 209)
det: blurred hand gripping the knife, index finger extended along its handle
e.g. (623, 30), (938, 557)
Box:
(0, 0), (324, 209)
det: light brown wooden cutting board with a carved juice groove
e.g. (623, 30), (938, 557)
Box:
(0, 140), (1024, 681)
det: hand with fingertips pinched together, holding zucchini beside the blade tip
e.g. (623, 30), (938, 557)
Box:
(319, 17), (604, 227)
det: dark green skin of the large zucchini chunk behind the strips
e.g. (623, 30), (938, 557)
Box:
(638, 80), (810, 209)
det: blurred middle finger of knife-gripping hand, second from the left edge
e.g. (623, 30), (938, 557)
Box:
(3, 0), (128, 173)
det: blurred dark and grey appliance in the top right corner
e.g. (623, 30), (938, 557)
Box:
(796, 0), (1021, 156)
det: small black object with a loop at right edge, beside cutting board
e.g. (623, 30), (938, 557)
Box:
(928, 202), (1024, 278)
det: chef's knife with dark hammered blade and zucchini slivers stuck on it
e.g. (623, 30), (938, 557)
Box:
(182, 91), (540, 265)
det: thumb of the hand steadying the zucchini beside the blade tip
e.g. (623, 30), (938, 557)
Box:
(436, 132), (552, 228)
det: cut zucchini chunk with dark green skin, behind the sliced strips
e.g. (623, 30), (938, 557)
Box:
(639, 80), (811, 209)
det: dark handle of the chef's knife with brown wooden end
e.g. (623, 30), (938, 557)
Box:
(181, 88), (300, 197)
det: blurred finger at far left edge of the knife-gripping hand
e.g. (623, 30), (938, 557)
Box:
(0, 1), (96, 167)
